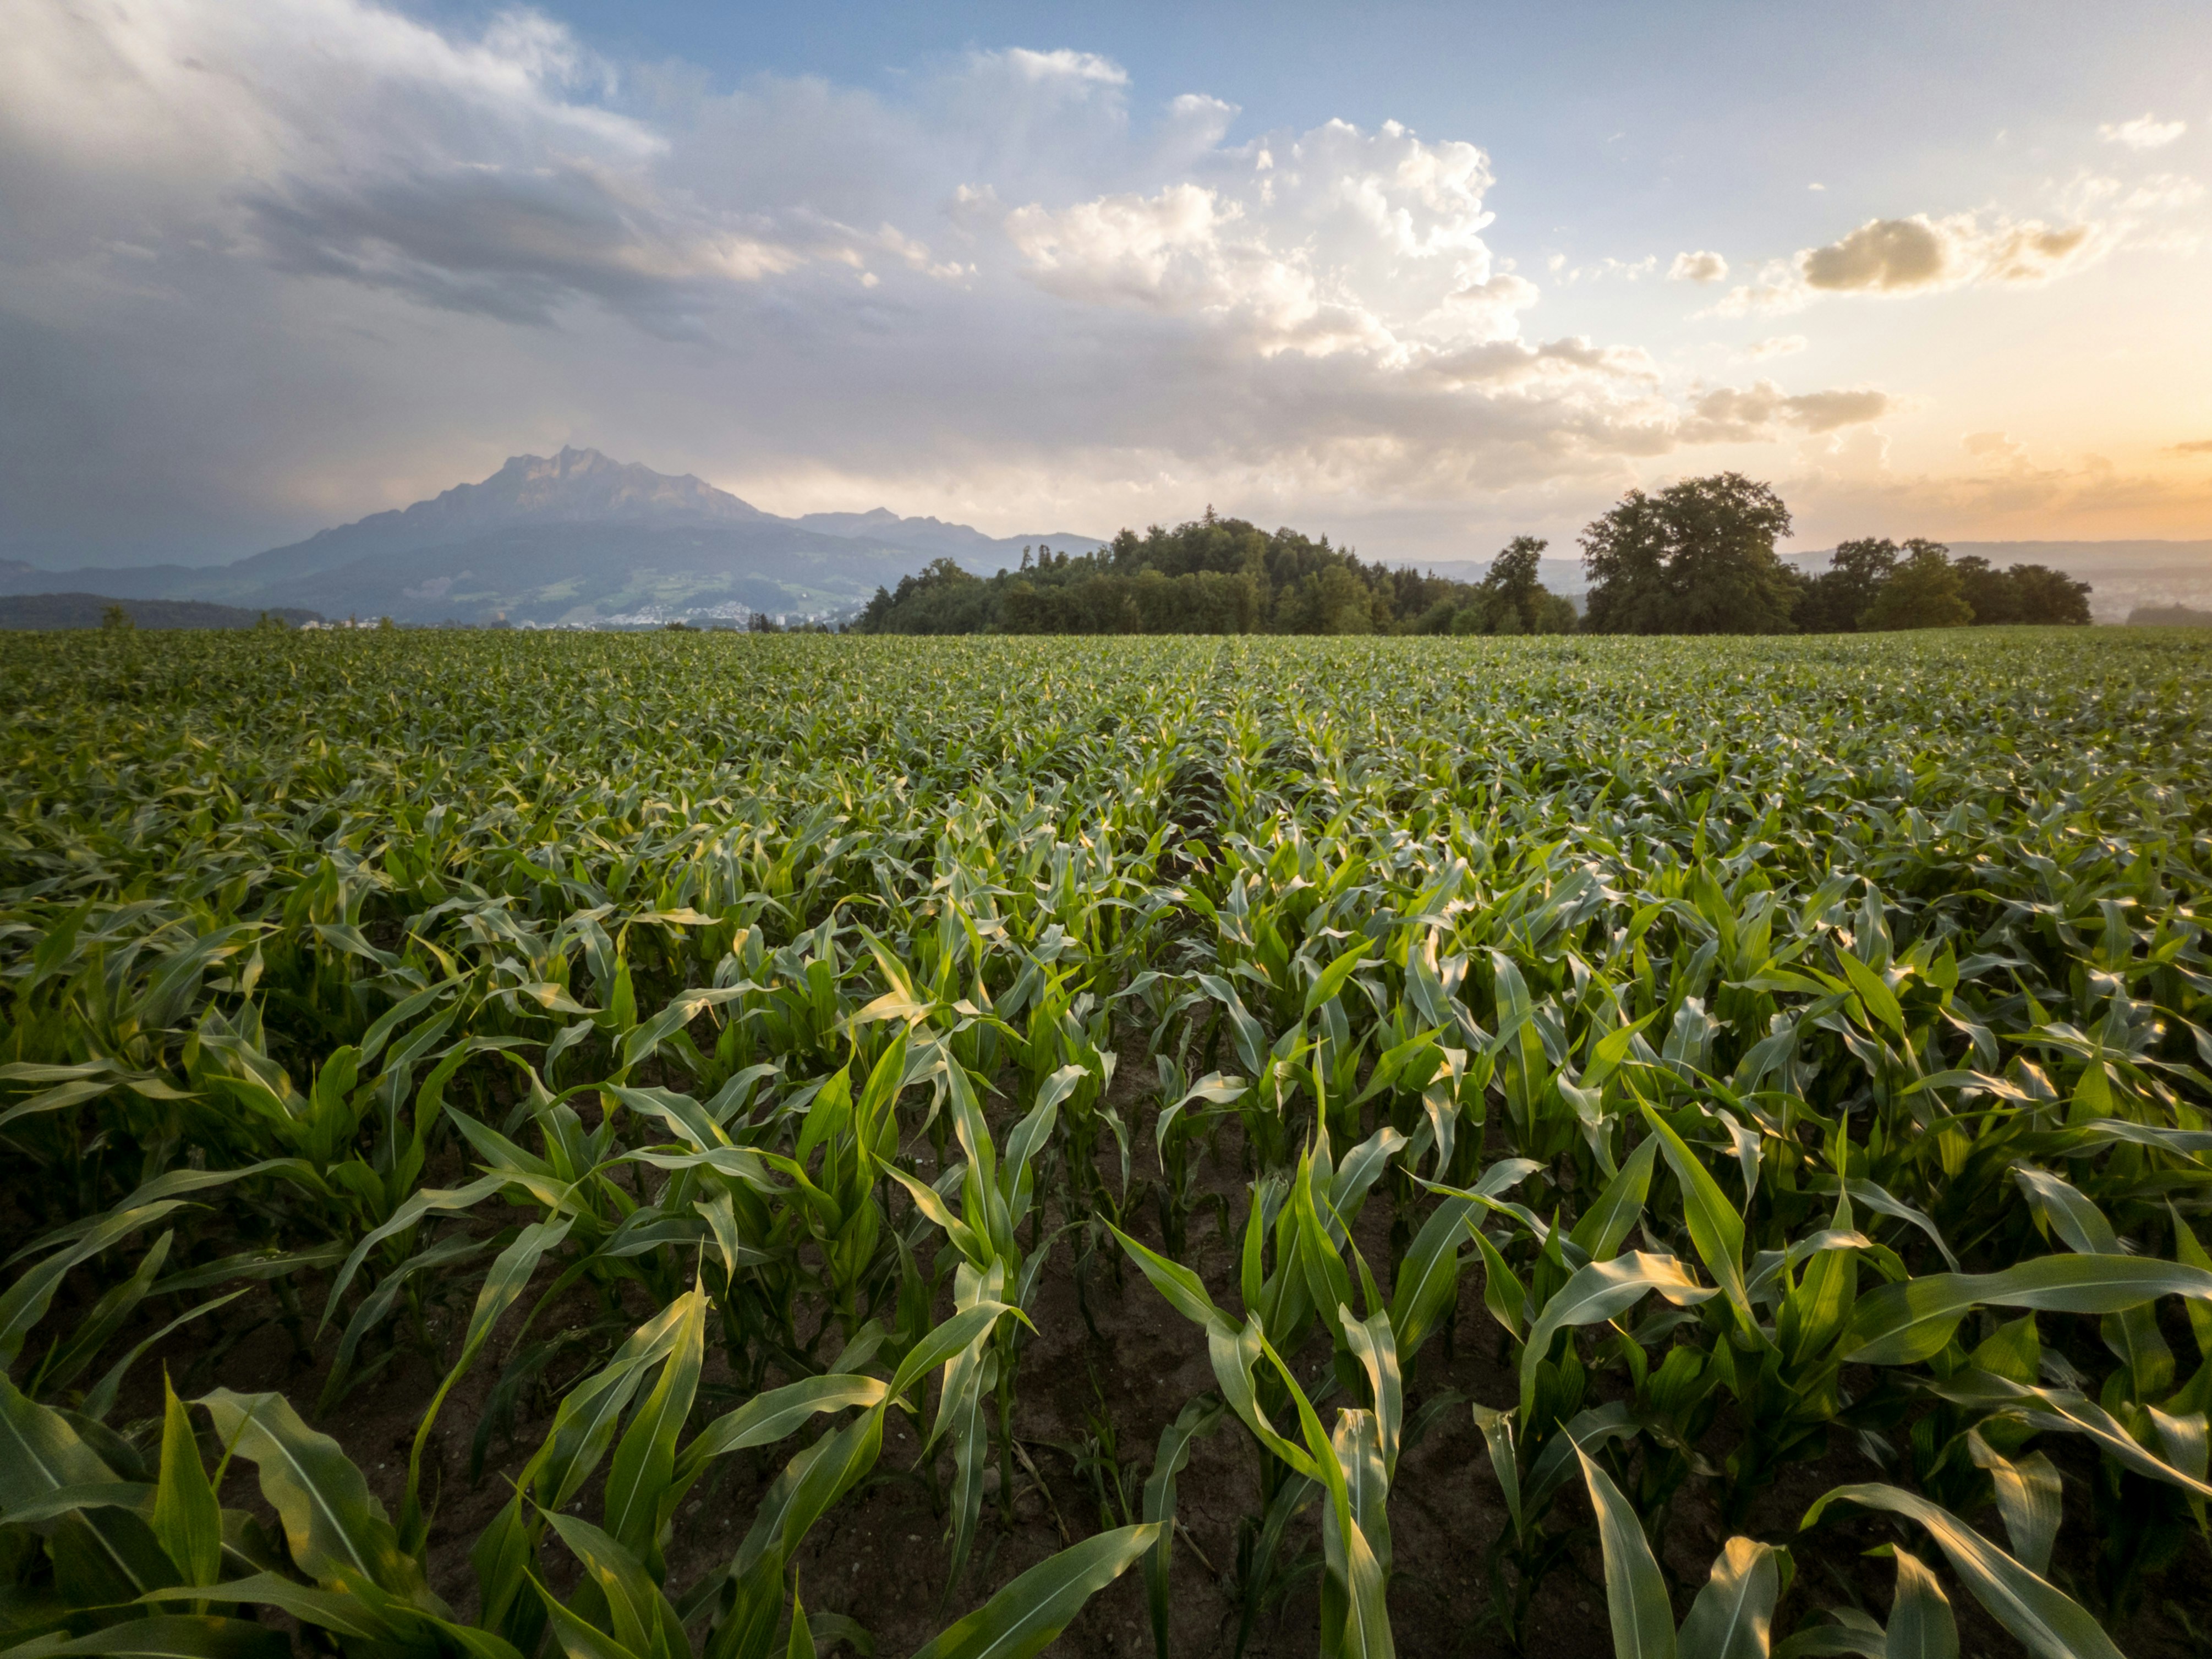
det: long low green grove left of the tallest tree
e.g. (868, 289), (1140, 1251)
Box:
(854, 509), (1575, 635)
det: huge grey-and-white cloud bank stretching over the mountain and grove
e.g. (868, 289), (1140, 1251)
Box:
(0, 0), (1887, 557)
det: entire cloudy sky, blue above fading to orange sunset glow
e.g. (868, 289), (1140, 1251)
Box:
(0, 0), (2212, 566)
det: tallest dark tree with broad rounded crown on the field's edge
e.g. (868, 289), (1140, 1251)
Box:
(1581, 473), (1803, 633)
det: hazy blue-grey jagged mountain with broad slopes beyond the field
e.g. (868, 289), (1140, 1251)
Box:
(0, 449), (1099, 626)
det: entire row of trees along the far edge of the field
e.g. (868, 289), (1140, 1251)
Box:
(852, 473), (2090, 635)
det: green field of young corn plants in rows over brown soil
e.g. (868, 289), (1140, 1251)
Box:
(0, 631), (2212, 1659)
